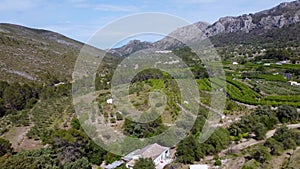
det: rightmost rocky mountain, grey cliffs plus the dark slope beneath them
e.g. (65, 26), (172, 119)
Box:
(204, 0), (300, 46)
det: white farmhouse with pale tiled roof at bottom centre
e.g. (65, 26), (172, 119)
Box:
(122, 143), (170, 168)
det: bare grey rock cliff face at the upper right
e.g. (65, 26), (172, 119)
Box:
(204, 0), (300, 37)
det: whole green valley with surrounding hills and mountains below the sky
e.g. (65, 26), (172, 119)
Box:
(0, 0), (300, 169)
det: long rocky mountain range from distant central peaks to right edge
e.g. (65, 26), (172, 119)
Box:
(109, 0), (300, 56)
